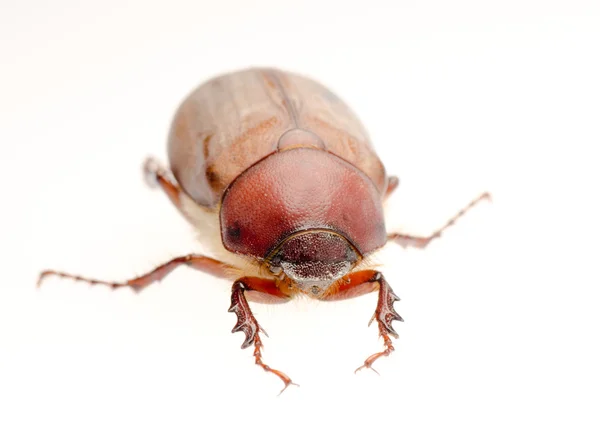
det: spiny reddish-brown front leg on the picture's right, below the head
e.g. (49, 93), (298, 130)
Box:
(324, 270), (404, 373)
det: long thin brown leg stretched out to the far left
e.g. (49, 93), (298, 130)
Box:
(37, 254), (233, 291)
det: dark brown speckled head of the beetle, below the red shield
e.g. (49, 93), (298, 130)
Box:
(269, 230), (360, 296)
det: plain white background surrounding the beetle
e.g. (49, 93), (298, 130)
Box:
(0, 0), (600, 422)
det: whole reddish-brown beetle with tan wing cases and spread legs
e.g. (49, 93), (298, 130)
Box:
(38, 68), (489, 392)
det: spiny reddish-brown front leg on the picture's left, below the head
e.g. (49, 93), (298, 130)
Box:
(229, 277), (298, 394)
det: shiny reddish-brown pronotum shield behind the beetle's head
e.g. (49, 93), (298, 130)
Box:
(220, 148), (386, 258)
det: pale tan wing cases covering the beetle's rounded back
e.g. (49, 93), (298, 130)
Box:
(168, 69), (386, 208)
